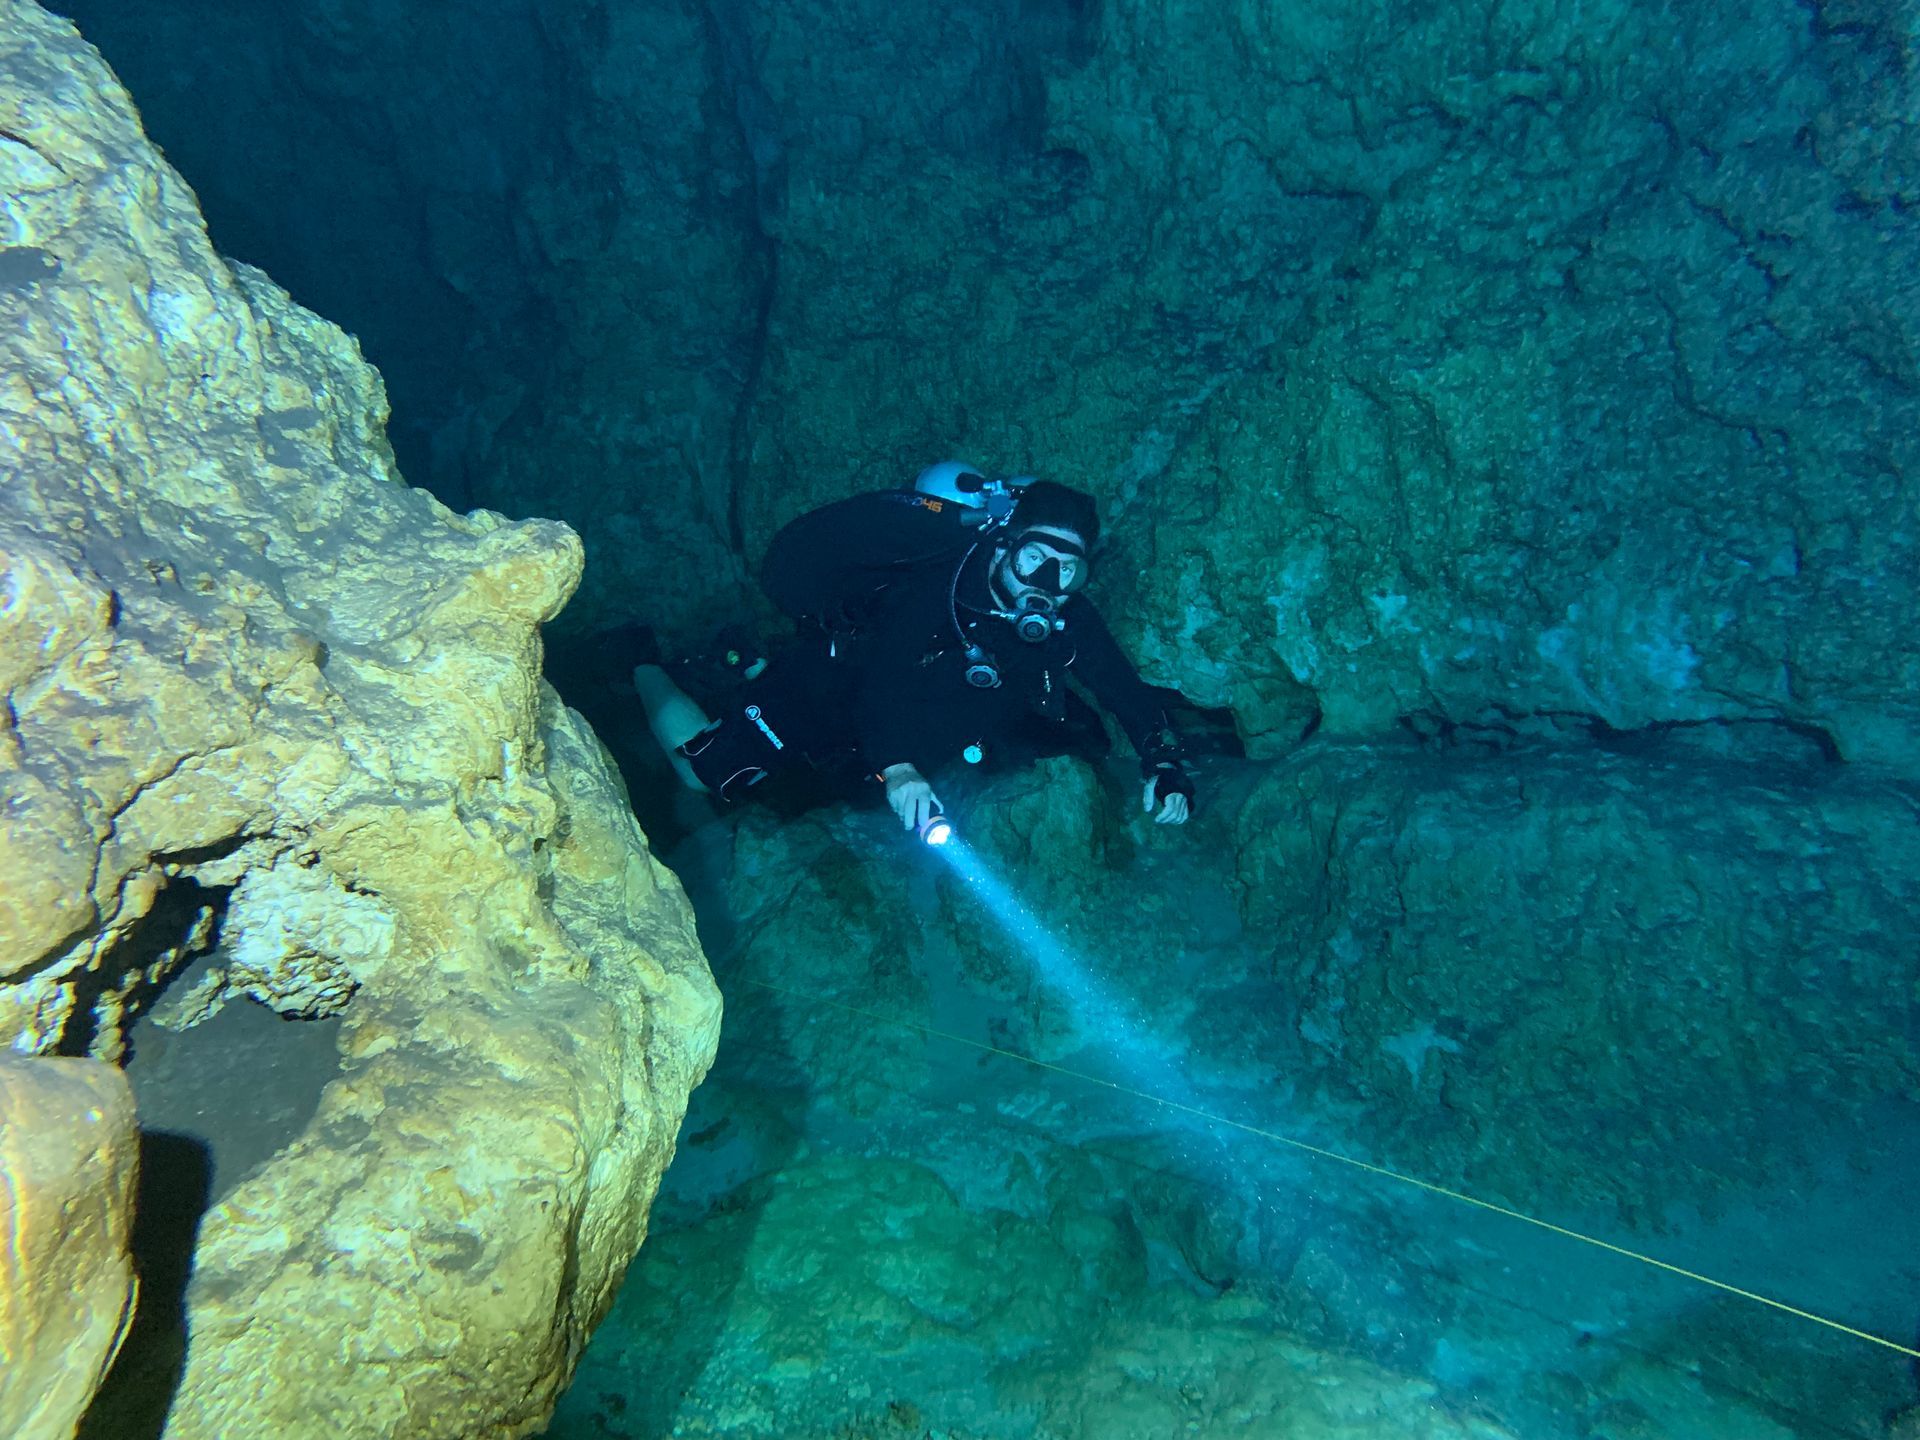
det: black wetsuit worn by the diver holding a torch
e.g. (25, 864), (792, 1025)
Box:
(682, 490), (1179, 799)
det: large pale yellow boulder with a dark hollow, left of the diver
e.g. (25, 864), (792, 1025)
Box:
(0, 0), (718, 1438)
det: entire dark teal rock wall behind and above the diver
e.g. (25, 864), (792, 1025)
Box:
(60, 0), (1920, 764)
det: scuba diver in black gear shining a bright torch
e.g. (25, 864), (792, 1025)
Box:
(632, 461), (1192, 829)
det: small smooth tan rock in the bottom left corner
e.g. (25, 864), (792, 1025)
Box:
(0, 1054), (140, 1440)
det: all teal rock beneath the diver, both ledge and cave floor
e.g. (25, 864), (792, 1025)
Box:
(537, 732), (1920, 1440)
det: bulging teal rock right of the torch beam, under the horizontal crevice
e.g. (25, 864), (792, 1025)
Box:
(1213, 745), (1920, 1217)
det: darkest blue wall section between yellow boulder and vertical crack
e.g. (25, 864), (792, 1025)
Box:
(50, 0), (778, 634)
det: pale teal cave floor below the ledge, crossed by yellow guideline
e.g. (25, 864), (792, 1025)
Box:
(547, 771), (1920, 1440)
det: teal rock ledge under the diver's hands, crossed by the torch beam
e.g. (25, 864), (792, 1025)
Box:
(710, 733), (1920, 1223)
